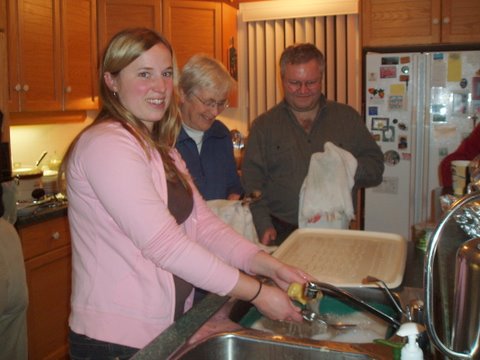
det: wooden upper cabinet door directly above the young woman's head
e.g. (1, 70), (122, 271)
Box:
(98, 0), (162, 53)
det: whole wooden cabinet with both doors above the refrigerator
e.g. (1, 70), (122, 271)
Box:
(362, 0), (480, 47)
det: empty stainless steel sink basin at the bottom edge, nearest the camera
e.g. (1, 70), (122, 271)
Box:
(170, 330), (386, 360)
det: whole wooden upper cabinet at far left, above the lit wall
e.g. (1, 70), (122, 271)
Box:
(7, 0), (97, 112)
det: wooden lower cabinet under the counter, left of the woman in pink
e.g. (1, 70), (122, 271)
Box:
(18, 216), (72, 360)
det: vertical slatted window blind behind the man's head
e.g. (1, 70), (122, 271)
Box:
(238, 11), (361, 124)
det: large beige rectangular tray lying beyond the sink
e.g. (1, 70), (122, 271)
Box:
(273, 229), (407, 288)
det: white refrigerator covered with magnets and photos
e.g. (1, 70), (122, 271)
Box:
(363, 50), (480, 240)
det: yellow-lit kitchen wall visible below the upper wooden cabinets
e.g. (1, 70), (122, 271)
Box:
(10, 108), (247, 167)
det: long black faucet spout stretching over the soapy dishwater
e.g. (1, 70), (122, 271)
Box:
(304, 281), (401, 329)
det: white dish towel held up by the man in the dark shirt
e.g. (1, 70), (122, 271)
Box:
(298, 142), (358, 229)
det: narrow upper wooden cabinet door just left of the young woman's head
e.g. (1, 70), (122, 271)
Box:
(62, 0), (98, 110)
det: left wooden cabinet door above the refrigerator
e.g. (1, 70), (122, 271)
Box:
(361, 0), (441, 46)
